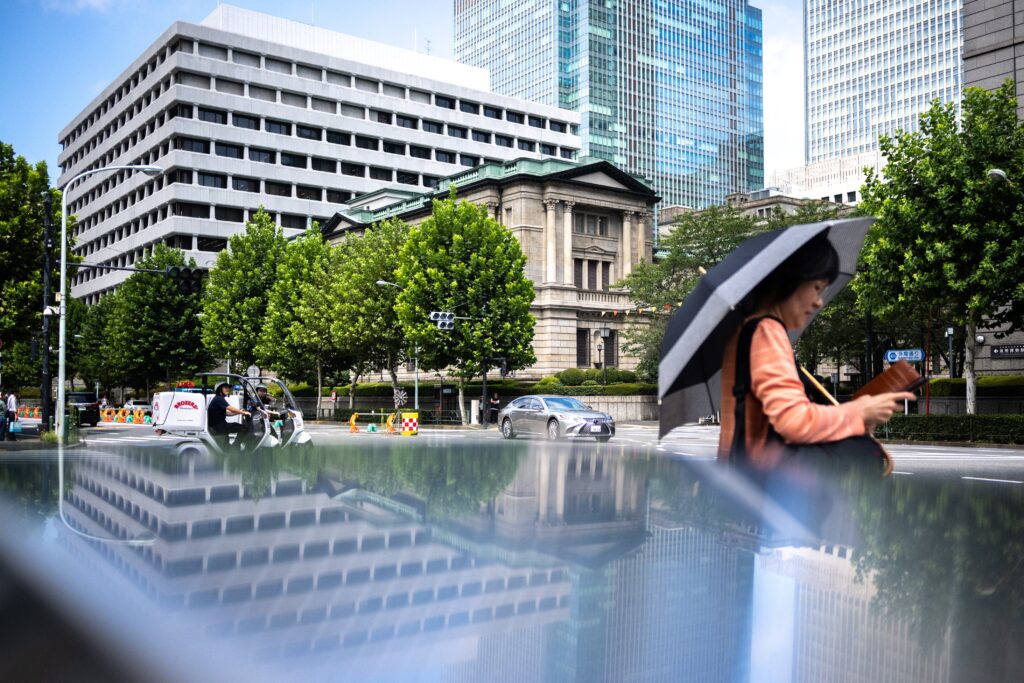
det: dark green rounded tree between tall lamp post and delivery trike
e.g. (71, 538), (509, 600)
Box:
(106, 245), (213, 395)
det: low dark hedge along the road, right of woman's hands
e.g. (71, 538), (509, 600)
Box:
(876, 415), (1024, 443)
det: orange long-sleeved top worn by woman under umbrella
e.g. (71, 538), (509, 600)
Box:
(718, 317), (865, 468)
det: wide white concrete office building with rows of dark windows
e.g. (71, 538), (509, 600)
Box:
(59, 5), (580, 303)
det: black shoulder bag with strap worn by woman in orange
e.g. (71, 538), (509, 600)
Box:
(729, 315), (892, 475)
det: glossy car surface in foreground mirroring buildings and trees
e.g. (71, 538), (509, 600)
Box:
(0, 437), (1024, 682)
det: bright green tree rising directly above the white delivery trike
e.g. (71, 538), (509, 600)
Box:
(203, 207), (287, 368)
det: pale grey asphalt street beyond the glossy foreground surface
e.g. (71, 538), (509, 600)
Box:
(74, 423), (1024, 486)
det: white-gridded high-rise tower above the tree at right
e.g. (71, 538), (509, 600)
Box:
(804, 0), (963, 164)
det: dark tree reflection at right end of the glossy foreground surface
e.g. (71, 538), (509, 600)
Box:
(855, 477), (1024, 681)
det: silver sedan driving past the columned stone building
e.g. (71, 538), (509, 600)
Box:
(498, 396), (615, 441)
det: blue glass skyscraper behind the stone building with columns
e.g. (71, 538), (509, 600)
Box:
(455, 0), (764, 208)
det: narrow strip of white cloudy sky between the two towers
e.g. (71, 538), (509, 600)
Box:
(754, 0), (804, 179)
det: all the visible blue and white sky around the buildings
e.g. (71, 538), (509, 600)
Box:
(0, 0), (803, 181)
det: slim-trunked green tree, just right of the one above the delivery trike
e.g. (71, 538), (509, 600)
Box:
(256, 225), (350, 415)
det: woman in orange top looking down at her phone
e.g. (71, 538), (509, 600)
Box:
(719, 234), (914, 469)
